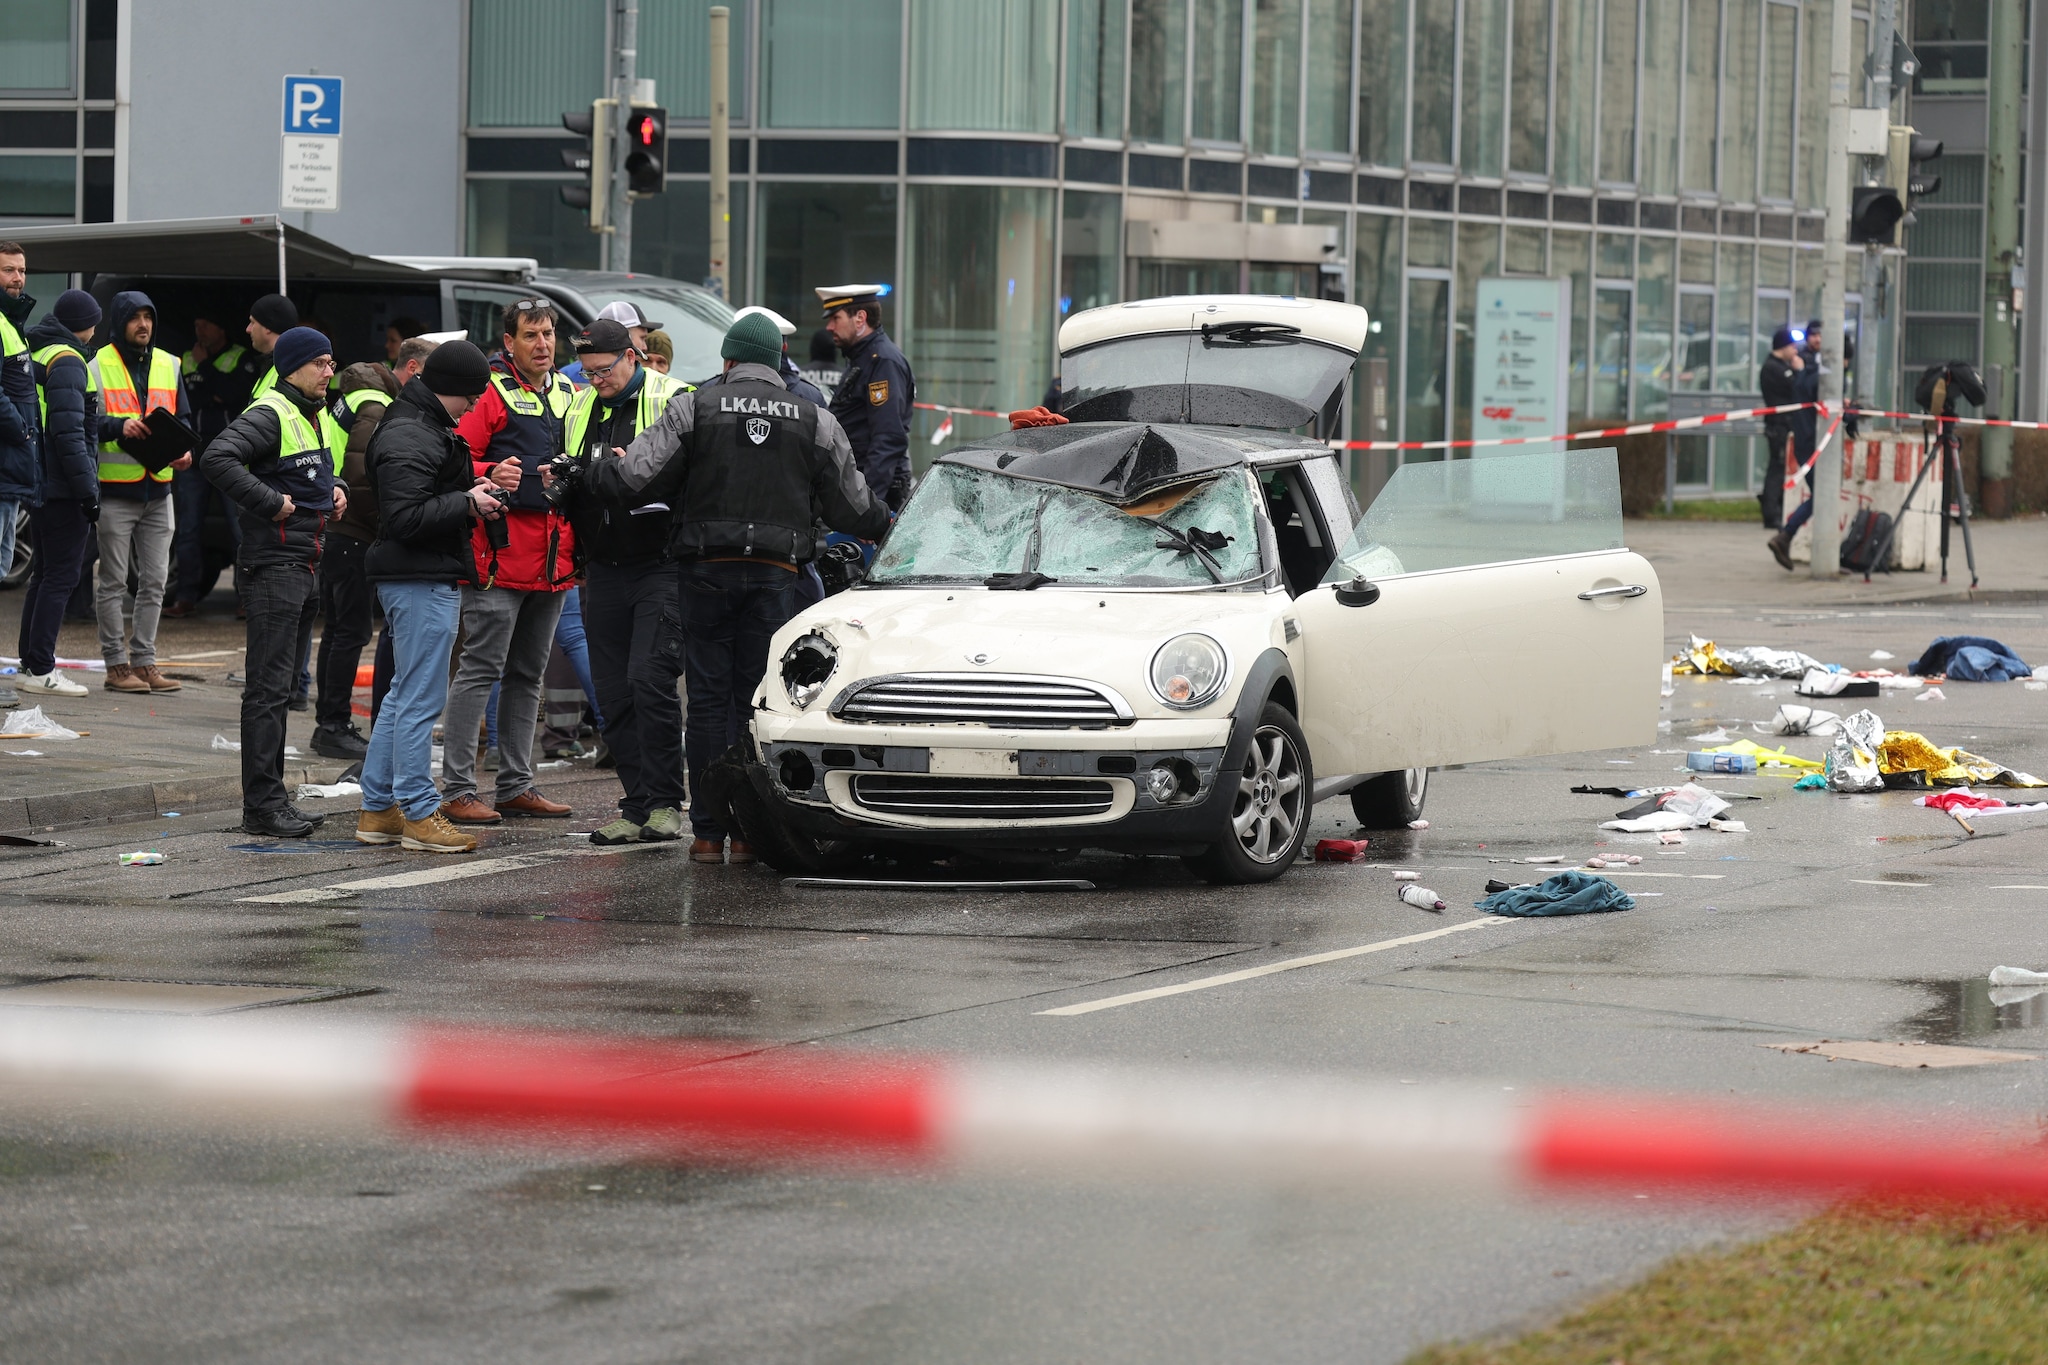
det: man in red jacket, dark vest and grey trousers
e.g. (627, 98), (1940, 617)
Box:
(440, 299), (575, 825)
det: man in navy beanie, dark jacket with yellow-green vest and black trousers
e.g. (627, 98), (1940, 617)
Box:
(201, 327), (348, 839)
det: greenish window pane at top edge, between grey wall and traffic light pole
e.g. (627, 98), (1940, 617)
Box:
(469, 0), (606, 128)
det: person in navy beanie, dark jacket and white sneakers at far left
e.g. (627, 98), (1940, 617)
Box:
(16, 289), (100, 696)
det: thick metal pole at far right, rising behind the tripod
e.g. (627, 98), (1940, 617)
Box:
(1976, 0), (2025, 518)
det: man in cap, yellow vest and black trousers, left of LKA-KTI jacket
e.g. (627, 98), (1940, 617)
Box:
(549, 317), (690, 843)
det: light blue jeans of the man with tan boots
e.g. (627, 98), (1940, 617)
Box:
(362, 583), (463, 821)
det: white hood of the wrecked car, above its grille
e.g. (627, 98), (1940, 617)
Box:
(762, 587), (1290, 718)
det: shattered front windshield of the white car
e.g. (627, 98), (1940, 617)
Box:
(868, 465), (1264, 589)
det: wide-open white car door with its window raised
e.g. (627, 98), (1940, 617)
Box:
(1294, 448), (1663, 776)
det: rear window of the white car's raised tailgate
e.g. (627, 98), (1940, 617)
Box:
(1059, 323), (1354, 430)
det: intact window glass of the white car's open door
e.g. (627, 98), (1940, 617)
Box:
(1323, 446), (1622, 583)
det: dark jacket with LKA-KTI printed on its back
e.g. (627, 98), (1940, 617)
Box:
(590, 362), (889, 565)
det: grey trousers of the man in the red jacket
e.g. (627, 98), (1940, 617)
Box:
(440, 587), (561, 806)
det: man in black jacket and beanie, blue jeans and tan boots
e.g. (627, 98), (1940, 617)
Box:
(356, 342), (504, 853)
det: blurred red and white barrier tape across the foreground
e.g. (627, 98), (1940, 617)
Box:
(0, 1009), (2048, 1203)
